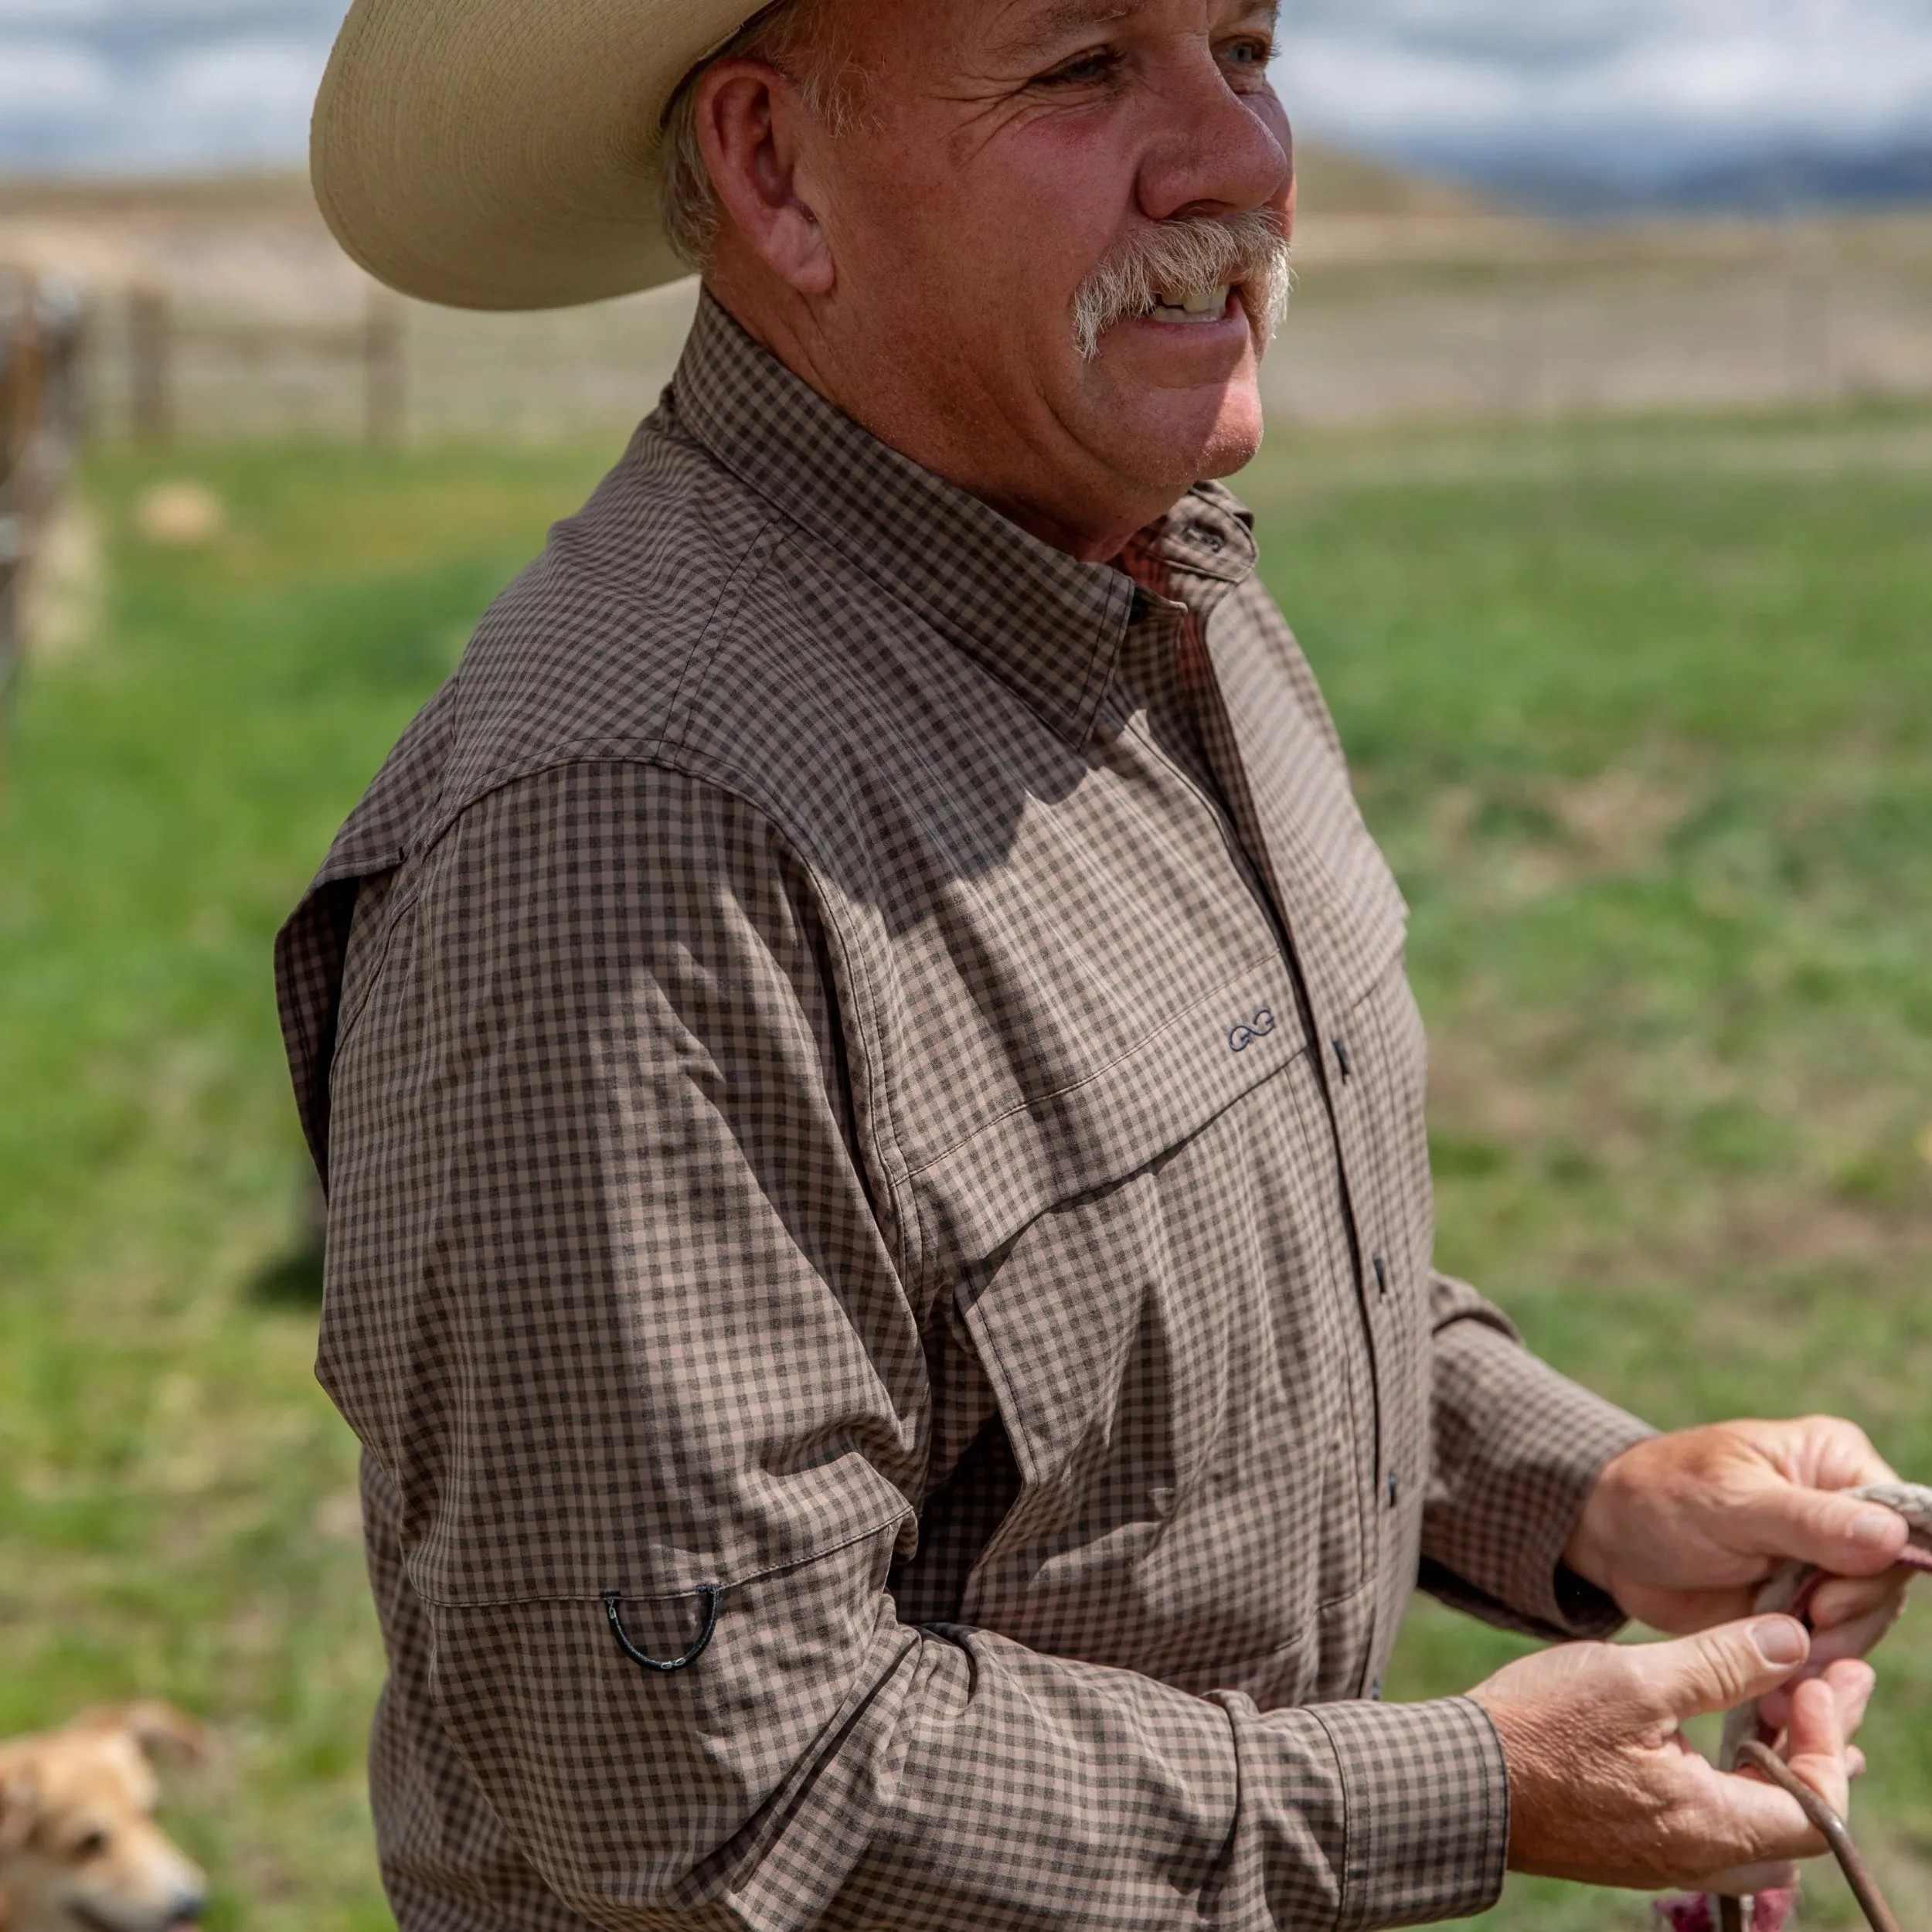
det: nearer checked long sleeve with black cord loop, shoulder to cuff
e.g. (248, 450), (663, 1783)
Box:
(321, 764), (1507, 1932)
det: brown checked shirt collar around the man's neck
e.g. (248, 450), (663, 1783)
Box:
(671, 294), (1254, 744)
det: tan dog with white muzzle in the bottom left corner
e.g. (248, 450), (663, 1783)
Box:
(0, 1702), (207, 1932)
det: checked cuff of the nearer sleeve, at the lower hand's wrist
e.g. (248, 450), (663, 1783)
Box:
(1308, 1696), (1509, 1932)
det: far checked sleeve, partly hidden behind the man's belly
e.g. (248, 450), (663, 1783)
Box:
(1422, 1275), (1654, 1638)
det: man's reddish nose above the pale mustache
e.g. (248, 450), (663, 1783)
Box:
(1136, 41), (1294, 223)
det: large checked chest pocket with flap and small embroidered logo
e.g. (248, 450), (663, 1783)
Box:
(893, 961), (1372, 1704)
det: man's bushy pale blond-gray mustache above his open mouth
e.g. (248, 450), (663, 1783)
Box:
(1073, 209), (1294, 362)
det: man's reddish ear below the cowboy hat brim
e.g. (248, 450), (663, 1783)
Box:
(696, 60), (833, 296)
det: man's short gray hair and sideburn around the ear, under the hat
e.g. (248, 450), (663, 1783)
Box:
(657, 0), (864, 270)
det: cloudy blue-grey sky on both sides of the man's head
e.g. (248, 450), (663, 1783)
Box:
(0, 0), (1932, 178)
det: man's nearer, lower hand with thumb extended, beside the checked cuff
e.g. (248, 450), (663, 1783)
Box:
(1471, 1617), (1872, 1892)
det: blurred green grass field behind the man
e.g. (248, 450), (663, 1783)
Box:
(11, 403), (1932, 1932)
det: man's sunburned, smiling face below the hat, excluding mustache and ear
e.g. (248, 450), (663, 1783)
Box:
(788, 0), (1294, 556)
